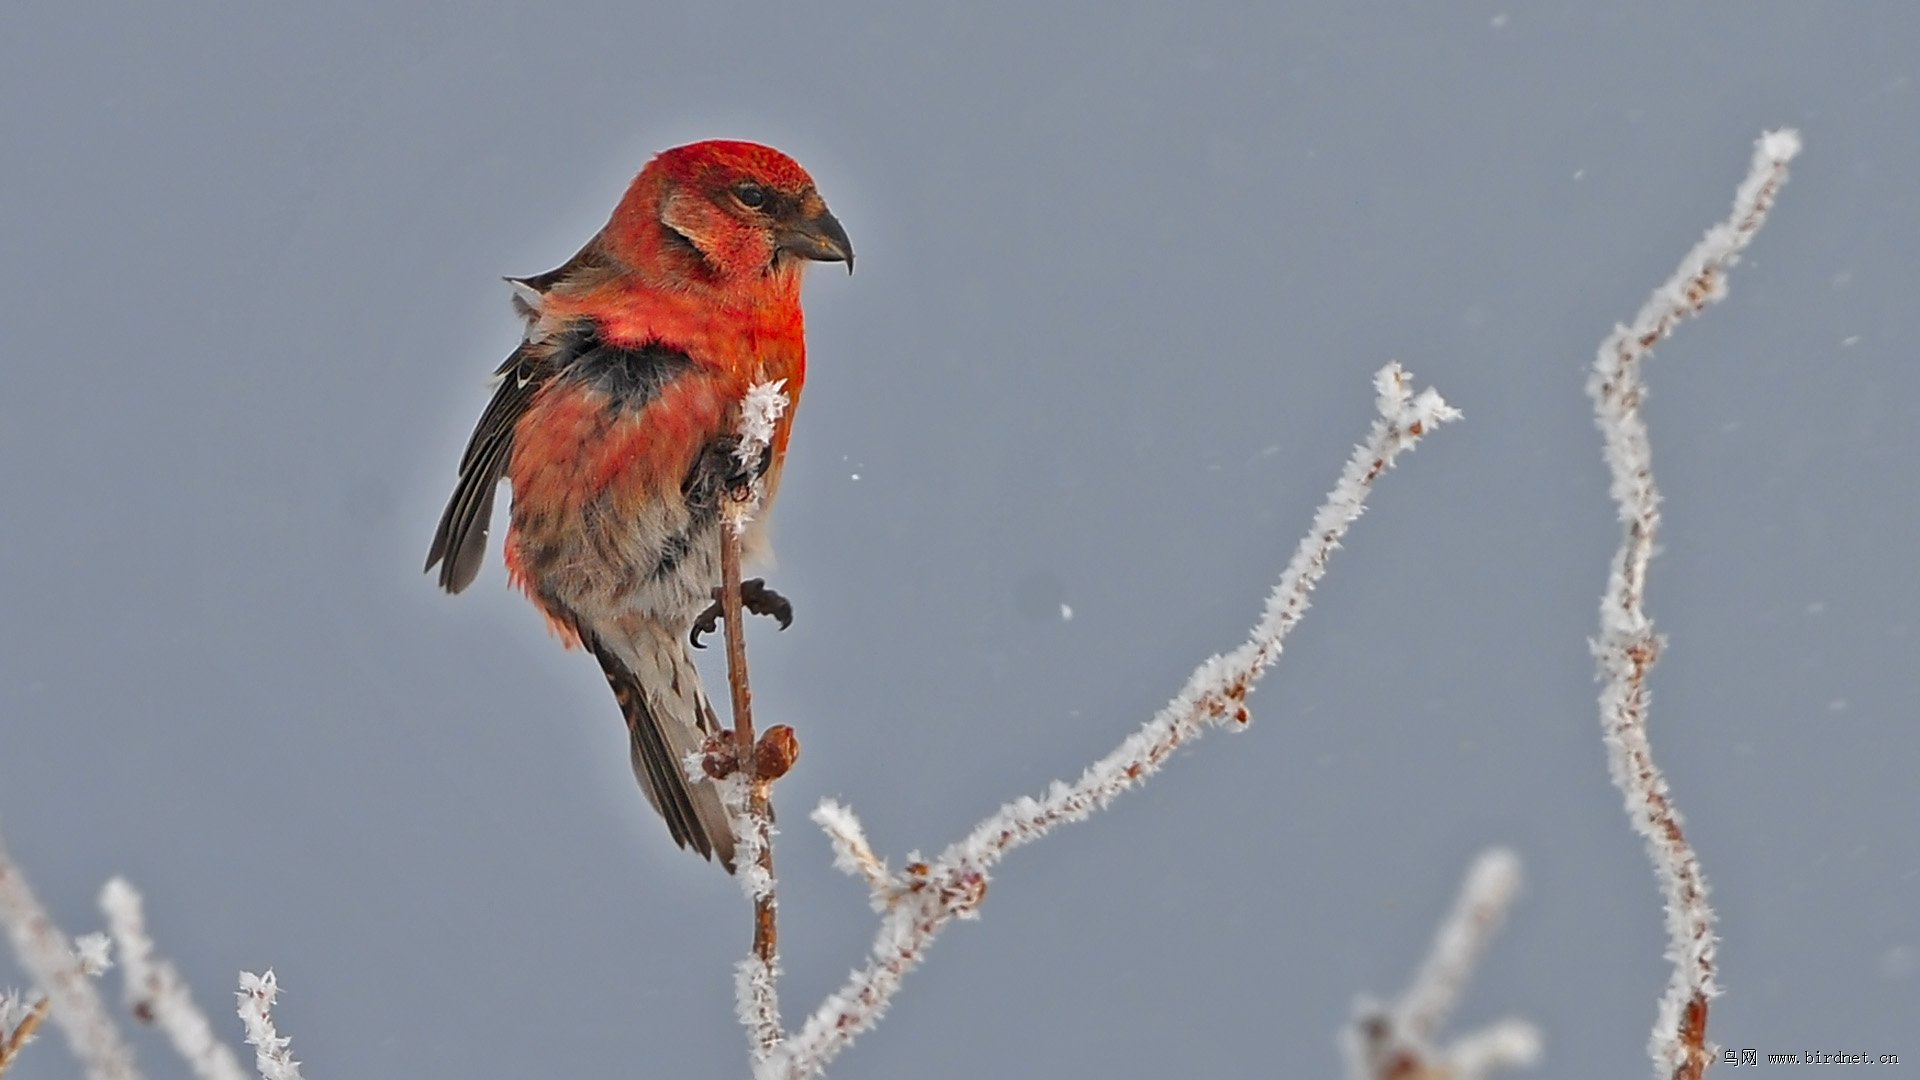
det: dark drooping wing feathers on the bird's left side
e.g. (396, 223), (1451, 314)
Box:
(426, 342), (561, 592)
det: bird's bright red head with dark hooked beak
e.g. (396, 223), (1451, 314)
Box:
(607, 138), (852, 290)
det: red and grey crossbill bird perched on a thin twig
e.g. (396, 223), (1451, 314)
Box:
(426, 140), (852, 871)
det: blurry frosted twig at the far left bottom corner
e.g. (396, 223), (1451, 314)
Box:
(0, 822), (140, 1080)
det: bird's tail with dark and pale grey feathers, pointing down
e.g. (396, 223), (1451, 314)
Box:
(588, 623), (733, 874)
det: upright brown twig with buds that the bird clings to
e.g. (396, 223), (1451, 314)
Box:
(718, 379), (799, 1067)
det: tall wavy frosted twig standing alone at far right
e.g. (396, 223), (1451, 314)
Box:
(1586, 131), (1801, 1080)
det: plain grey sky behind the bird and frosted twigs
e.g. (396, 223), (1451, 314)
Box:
(0, 2), (1920, 1080)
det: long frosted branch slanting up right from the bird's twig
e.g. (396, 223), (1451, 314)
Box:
(756, 363), (1459, 1080)
